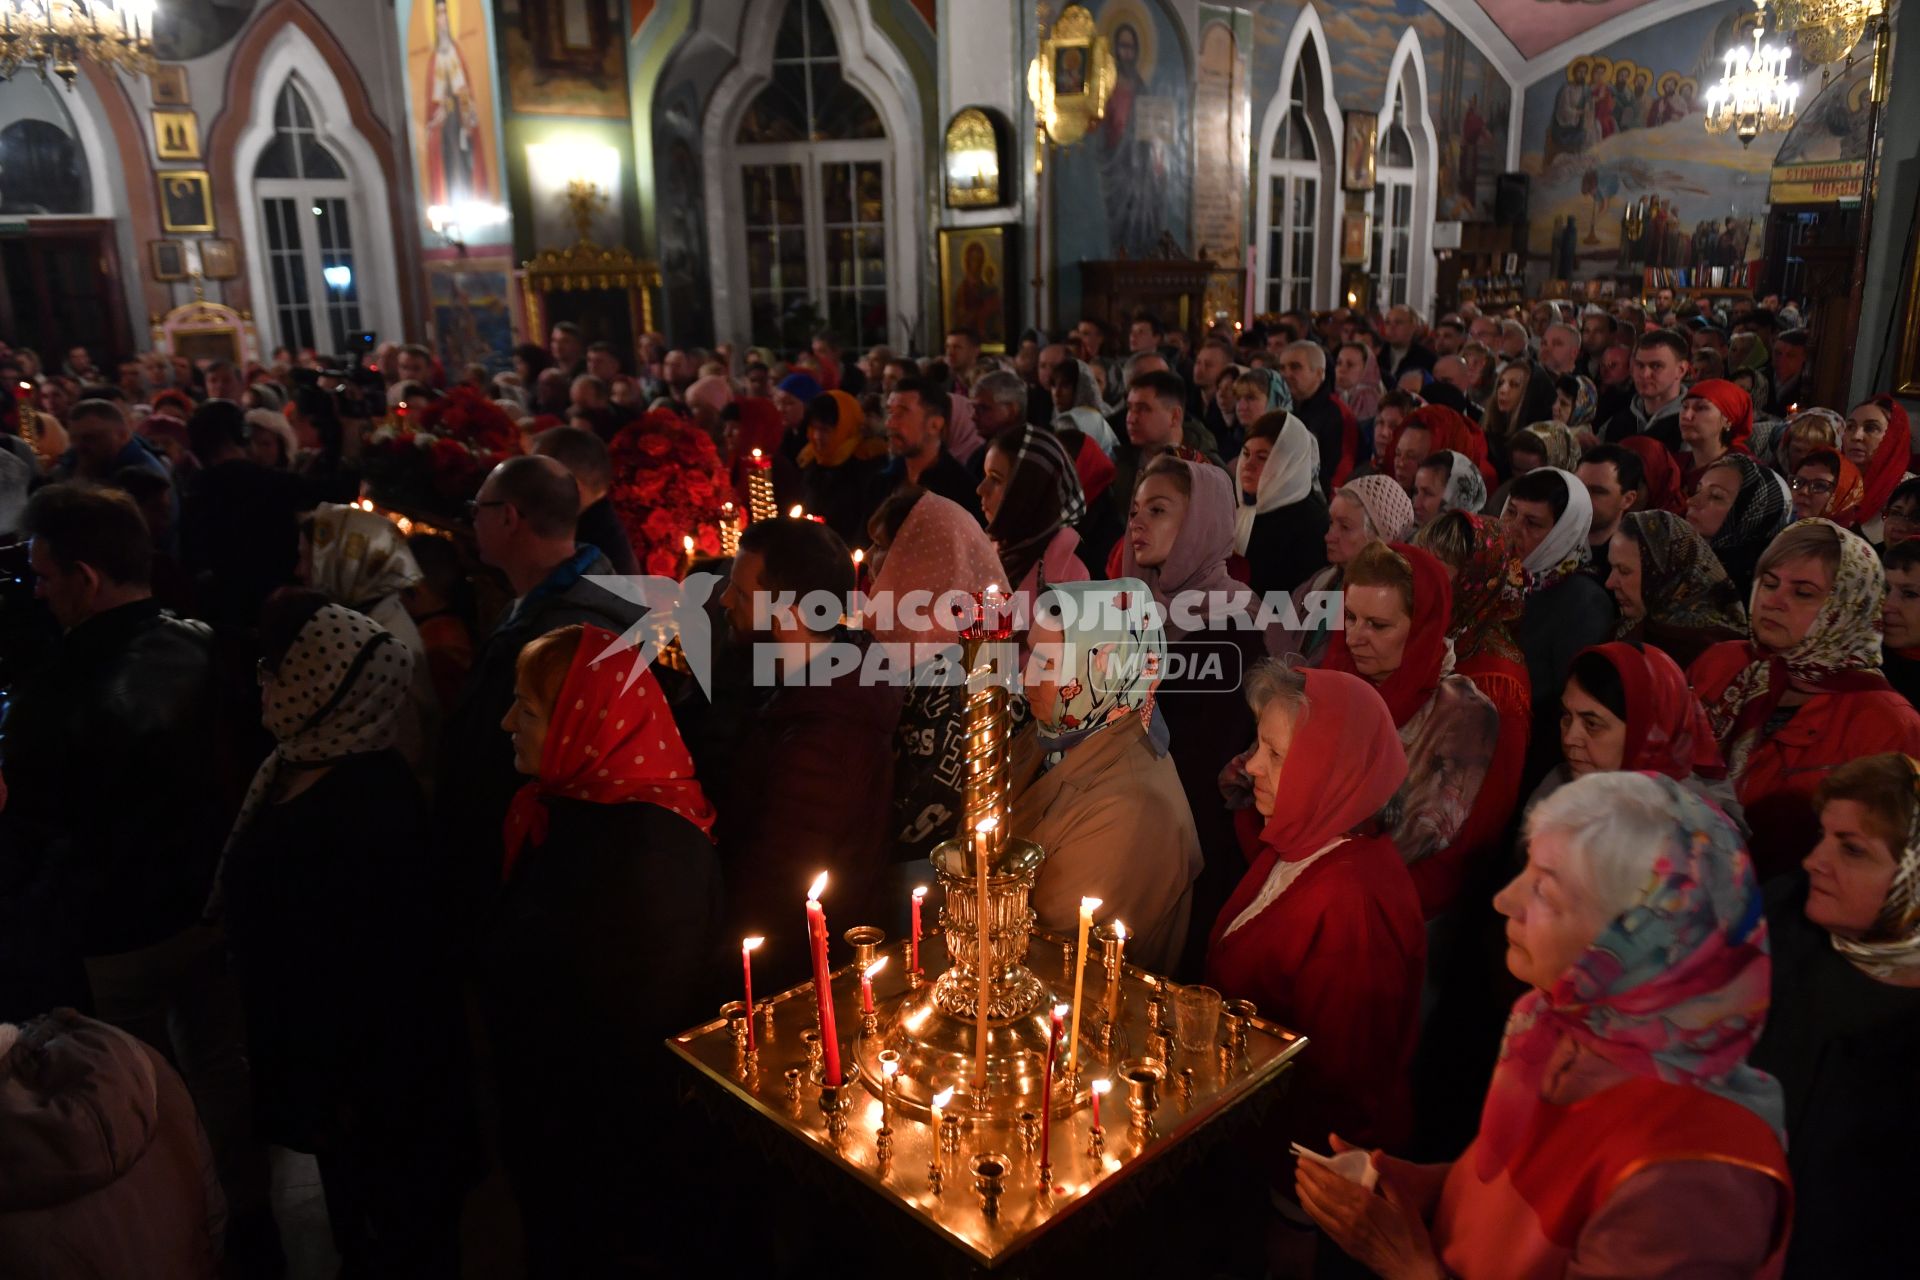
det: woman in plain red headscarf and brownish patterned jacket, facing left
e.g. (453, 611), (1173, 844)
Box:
(1321, 543), (1521, 919)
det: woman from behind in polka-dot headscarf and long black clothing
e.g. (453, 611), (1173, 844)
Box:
(215, 591), (467, 1274)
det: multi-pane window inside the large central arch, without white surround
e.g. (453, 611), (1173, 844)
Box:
(733, 0), (893, 349)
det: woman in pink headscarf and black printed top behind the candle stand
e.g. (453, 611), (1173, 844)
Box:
(868, 491), (1006, 862)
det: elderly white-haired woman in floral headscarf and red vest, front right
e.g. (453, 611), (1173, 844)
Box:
(1296, 773), (1789, 1280)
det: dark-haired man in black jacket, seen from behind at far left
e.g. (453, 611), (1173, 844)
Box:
(0, 484), (271, 1258)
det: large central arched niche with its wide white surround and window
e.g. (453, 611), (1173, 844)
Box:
(701, 0), (927, 349)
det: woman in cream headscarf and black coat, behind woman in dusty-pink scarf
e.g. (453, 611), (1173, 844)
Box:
(1233, 408), (1327, 597)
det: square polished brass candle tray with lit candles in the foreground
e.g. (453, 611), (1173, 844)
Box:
(666, 931), (1308, 1270)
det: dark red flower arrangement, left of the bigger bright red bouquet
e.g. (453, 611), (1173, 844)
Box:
(363, 386), (520, 516)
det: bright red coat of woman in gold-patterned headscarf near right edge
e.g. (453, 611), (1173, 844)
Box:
(1688, 641), (1920, 881)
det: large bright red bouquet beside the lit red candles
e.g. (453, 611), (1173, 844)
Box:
(609, 409), (733, 578)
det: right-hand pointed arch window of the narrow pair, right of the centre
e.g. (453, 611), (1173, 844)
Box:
(1371, 27), (1440, 315)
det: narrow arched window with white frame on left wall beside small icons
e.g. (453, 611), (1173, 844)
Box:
(253, 79), (365, 351)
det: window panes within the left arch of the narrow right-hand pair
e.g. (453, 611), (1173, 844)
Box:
(1260, 42), (1332, 311)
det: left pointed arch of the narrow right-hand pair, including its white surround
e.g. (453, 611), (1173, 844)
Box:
(1254, 6), (1340, 311)
